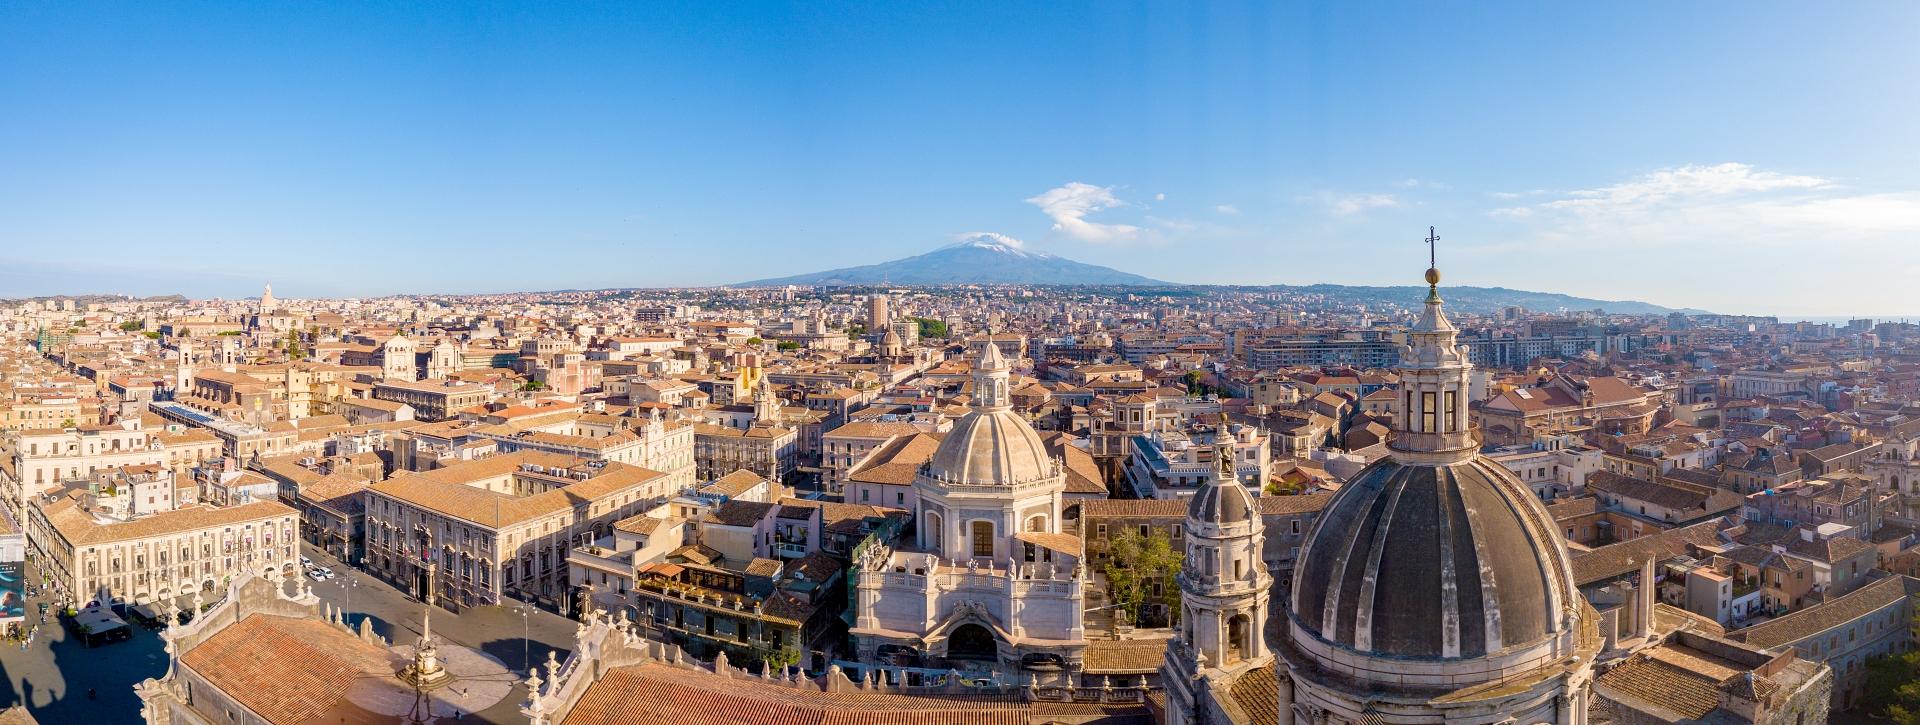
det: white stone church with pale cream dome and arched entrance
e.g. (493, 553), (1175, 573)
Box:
(851, 345), (1087, 683)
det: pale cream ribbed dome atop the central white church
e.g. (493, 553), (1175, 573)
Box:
(927, 408), (1054, 485)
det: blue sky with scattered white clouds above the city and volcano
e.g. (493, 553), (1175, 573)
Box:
(0, 2), (1920, 315)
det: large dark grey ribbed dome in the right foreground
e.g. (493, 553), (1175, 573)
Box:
(1294, 456), (1578, 660)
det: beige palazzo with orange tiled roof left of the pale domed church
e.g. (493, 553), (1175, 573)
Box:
(365, 451), (666, 608)
